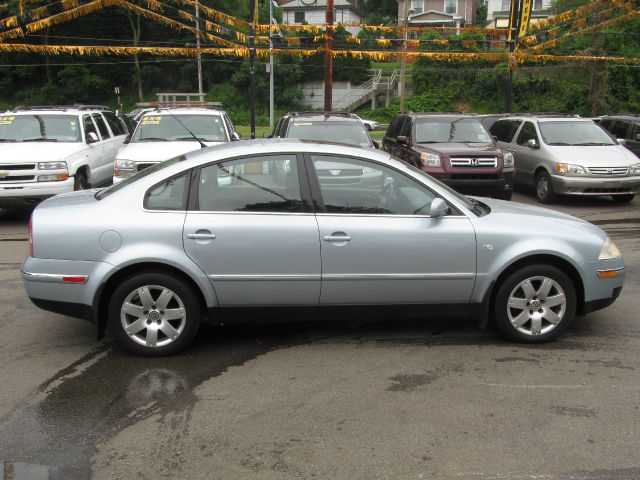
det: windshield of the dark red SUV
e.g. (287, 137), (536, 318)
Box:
(415, 118), (493, 143)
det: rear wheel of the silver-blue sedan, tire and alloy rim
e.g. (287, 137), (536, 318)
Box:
(109, 272), (201, 357)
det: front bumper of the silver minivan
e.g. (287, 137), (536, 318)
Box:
(551, 175), (640, 195)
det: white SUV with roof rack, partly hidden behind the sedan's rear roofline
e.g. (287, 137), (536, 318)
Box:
(113, 107), (240, 183)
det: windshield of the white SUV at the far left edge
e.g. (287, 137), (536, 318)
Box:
(0, 113), (80, 142)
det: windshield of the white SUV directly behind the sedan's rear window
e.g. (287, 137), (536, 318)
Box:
(131, 114), (227, 143)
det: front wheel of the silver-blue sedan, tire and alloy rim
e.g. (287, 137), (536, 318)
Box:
(493, 264), (577, 343)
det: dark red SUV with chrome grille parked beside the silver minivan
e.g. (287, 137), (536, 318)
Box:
(382, 113), (514, 200)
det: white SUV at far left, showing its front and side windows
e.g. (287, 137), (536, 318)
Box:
(0, 105), (127, 208)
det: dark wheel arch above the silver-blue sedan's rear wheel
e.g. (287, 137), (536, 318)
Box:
(93, 261), (207, 340)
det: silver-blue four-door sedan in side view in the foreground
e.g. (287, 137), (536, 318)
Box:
(22, 140), (625, 355)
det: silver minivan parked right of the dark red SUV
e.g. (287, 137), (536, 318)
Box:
(489, 115), (640, 203)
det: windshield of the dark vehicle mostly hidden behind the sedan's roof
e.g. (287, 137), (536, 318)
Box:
(287, 121), (373, 147)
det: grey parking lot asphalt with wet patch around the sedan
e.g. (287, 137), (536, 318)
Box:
(0, 192), (640, 480)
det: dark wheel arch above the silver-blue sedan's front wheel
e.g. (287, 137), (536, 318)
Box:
(485, 254), (584, 321)
